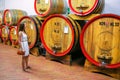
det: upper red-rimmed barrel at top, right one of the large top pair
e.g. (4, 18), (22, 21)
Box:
(68, 0), (105, 16)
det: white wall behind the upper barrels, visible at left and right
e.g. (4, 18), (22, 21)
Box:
(0, 0), (120, 15)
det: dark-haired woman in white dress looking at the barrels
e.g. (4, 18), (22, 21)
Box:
(18, 24), (30, 71)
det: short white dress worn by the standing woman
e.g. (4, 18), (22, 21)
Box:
(19, 31), (29, 56)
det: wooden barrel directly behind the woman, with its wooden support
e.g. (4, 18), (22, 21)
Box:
(18, 15), (44, 56)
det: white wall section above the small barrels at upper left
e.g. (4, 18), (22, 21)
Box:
(5, 0), (37, 15)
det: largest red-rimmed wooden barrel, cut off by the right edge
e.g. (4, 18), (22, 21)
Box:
(80, 14), (120, 68)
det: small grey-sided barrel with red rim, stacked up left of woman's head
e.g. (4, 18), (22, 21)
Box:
(4, 9), (27, 26)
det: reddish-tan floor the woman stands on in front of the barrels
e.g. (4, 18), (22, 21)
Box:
(0, 43), (116, 80)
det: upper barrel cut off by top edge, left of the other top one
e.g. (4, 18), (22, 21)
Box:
(34, 0), (67, 17)
